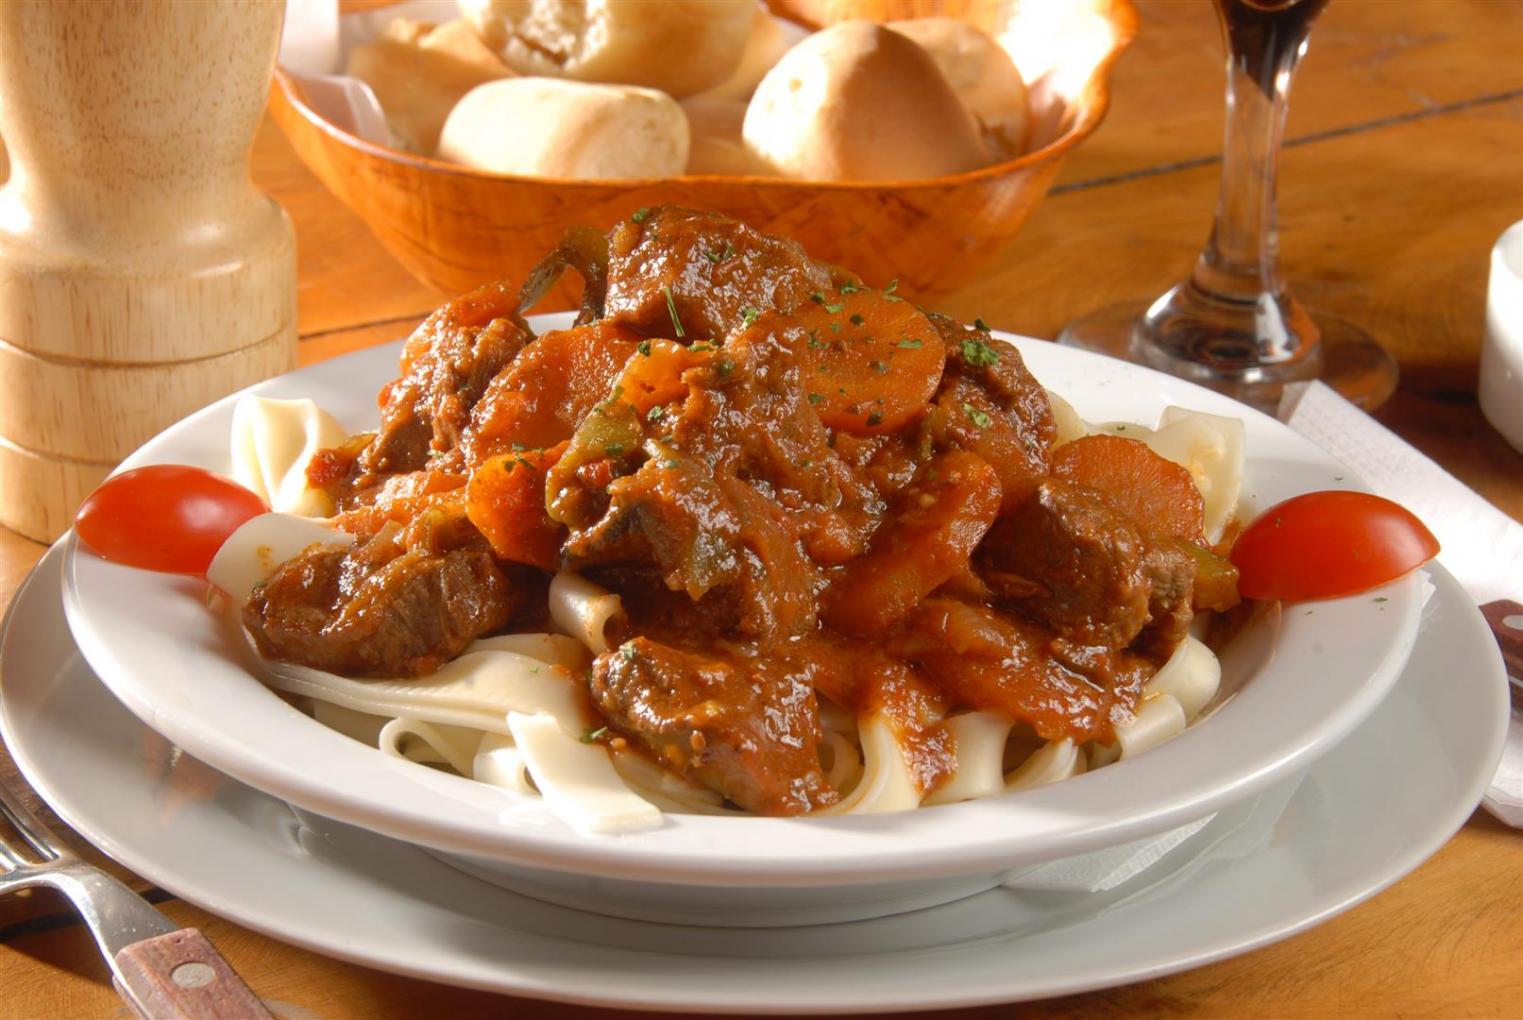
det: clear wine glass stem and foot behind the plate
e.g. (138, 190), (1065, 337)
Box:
(1058, 0), (1397, 413)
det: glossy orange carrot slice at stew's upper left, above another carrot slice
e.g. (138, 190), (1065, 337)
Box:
(463, 323), (640, 464)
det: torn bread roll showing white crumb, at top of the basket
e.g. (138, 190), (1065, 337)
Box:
(458, 0), (752, 97)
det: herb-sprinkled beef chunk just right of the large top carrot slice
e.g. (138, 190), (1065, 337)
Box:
(926, 315), (1057, 510)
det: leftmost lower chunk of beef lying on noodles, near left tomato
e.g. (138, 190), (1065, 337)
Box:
(244, 534), (515, 677)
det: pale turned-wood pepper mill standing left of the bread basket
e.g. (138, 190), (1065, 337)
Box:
(0, 0), (295, 540)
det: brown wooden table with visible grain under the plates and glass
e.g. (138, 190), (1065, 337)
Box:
(0, 0), (1523, 1017)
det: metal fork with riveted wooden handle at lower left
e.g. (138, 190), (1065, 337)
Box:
(0, 770), (274, 1020)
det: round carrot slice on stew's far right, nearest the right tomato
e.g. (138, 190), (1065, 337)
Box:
(1052, 435), (1205, 542)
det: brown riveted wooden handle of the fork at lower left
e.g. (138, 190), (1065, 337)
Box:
(116, 929), (274, 1020)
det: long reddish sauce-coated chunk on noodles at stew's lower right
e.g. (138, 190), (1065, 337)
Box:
(891, 597), (1154, 743)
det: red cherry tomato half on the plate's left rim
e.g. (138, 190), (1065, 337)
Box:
(75, 464), (270, 574)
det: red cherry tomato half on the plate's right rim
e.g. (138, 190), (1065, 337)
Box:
(1232, 492), (1438, 601)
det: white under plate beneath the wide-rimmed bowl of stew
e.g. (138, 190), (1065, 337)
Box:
(0, 548), (1506, 1012)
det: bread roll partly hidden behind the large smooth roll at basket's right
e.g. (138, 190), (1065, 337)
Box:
(888, 18), (1030, 160)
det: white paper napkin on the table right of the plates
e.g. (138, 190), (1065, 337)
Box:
(1281, 382), (1523, 828)
